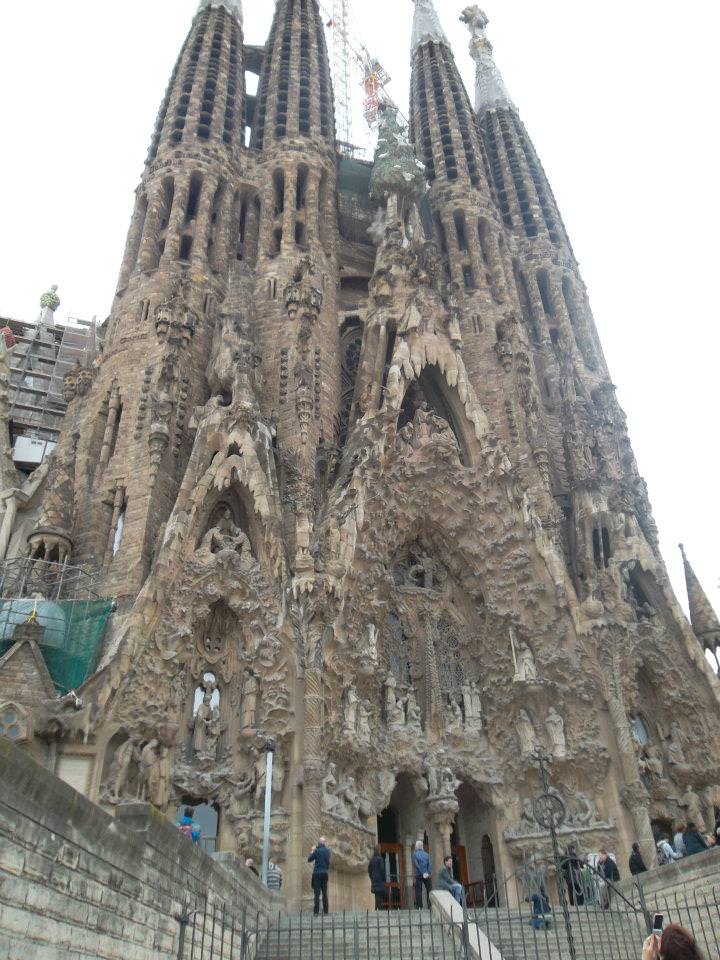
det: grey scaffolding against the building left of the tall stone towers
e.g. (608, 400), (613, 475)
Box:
(0, 317), (95, 470)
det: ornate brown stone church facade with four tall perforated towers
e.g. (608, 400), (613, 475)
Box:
(0, 0), (720, 908)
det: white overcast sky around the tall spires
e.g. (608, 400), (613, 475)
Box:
(0, 0), (720, 624)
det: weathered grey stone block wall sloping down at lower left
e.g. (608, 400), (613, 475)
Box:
(0, 741), (282, 960)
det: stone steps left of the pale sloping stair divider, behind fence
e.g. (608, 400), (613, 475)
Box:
(255, 910), (462, 960)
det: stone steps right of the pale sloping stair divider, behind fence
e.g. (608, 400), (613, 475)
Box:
(469, 907), (647, 960)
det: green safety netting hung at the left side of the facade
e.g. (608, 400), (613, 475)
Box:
(0, 599), (113, 693)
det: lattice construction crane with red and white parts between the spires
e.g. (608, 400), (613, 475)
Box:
(320, 0), (397, 153)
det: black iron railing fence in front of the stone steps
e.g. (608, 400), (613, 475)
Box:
(177, 873), (720, 960)
